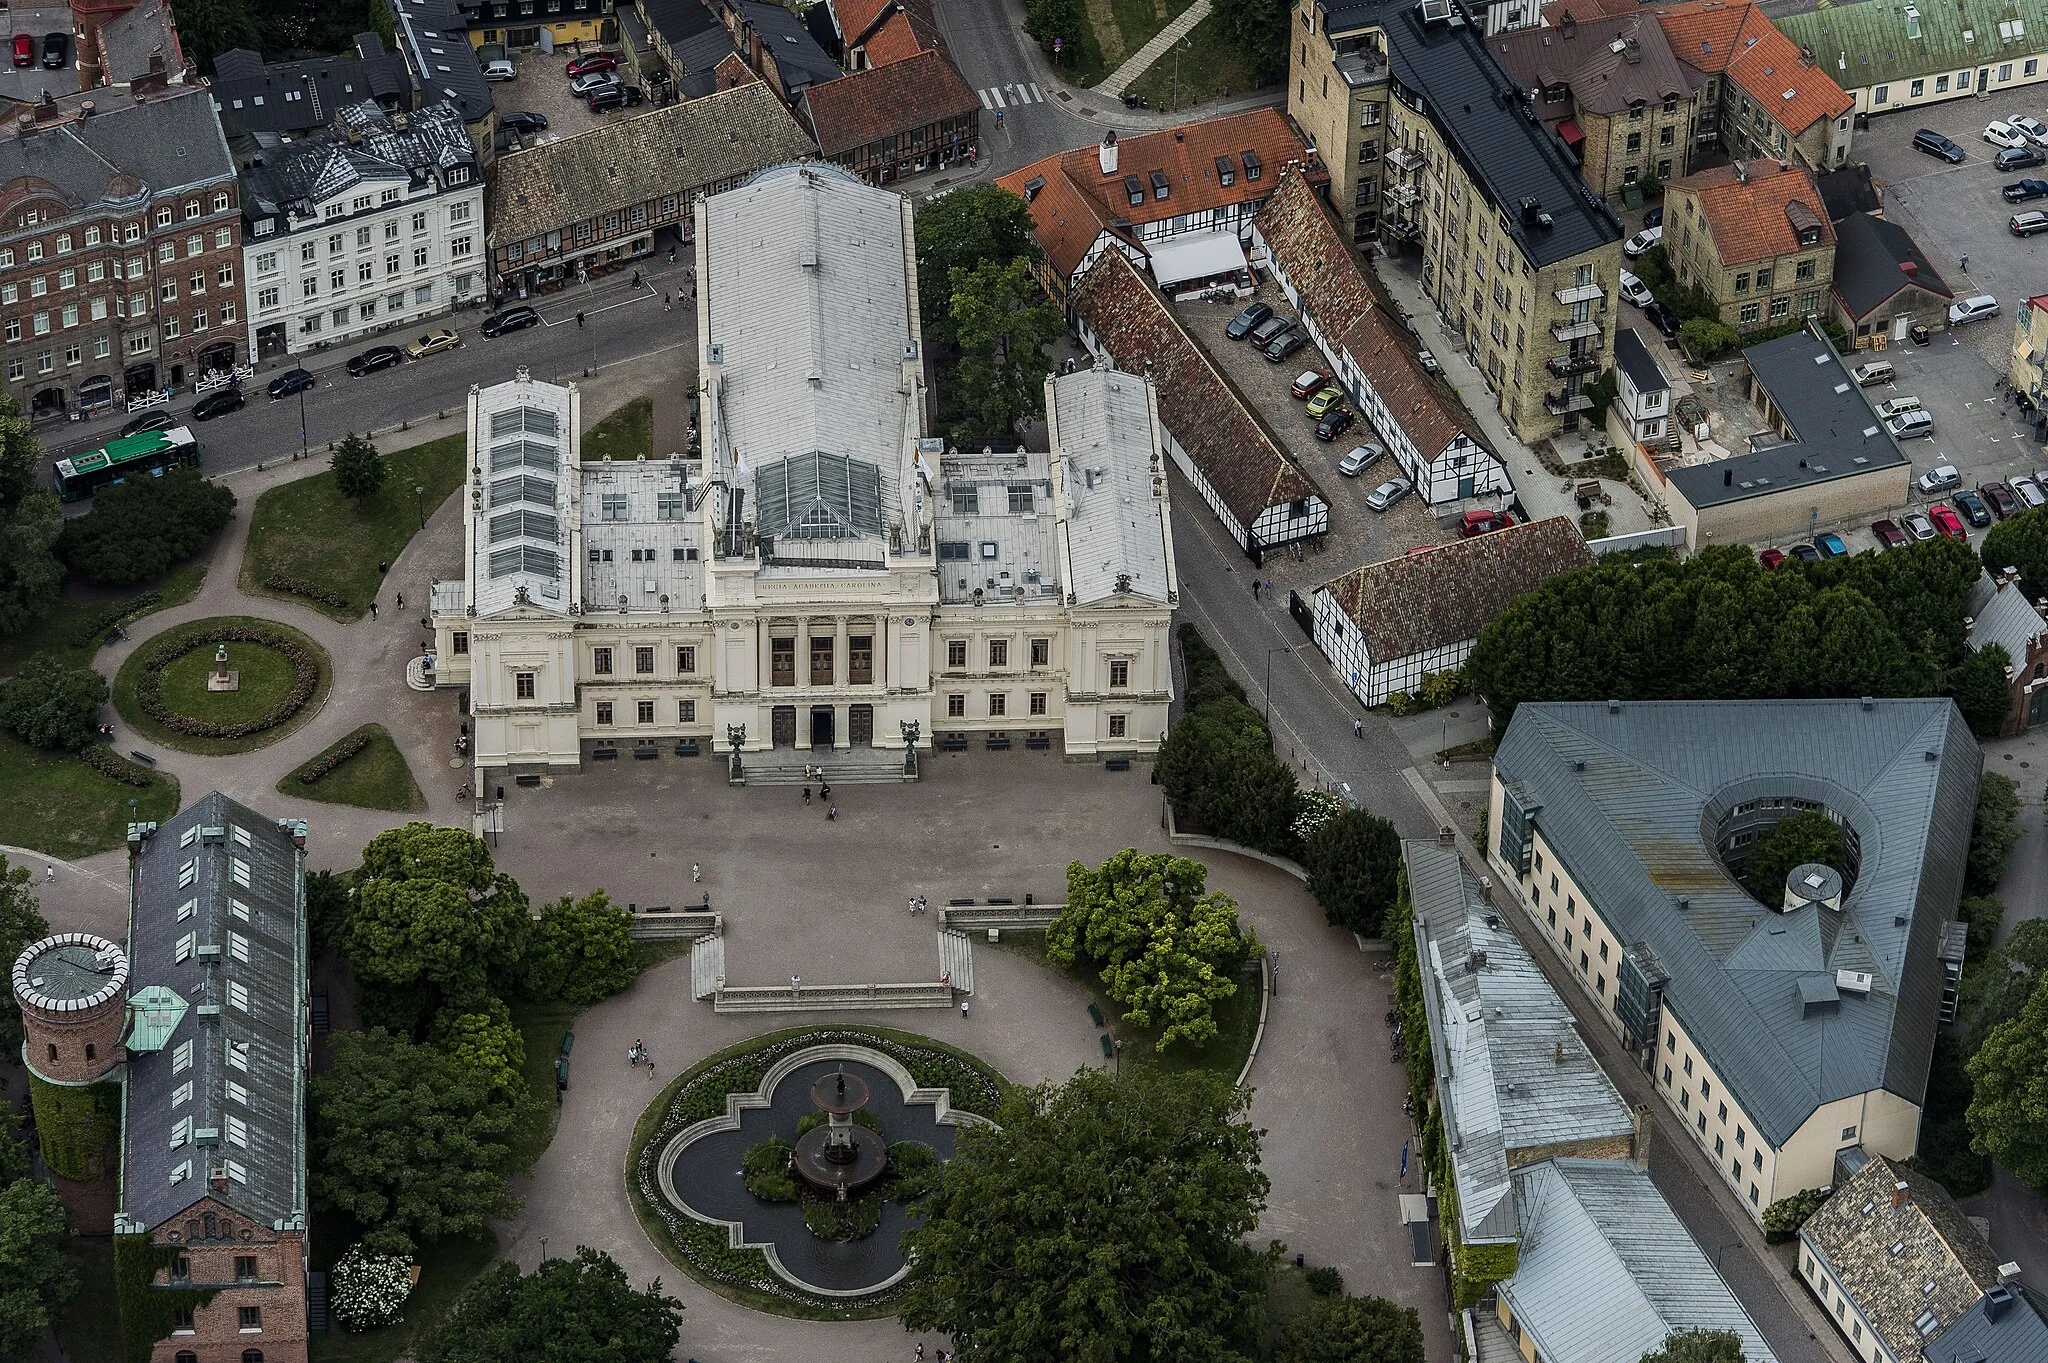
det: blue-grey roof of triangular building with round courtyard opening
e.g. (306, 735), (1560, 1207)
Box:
(1495, 700), (1982, 1146)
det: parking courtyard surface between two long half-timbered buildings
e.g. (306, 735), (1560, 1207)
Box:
(1169, 284), (1450, 573)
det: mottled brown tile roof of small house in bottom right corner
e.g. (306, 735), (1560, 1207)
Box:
(1800, 1156), (1999, 1363)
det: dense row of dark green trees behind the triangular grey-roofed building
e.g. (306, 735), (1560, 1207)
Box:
(1464, 536), (1978, 733)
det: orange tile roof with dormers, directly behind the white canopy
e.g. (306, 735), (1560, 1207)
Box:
(997, 108), (1329, 274)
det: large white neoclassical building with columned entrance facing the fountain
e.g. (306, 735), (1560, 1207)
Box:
(434, 164), (1180, 767)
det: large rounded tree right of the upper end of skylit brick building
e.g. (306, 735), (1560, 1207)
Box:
(340, 823), (528, 1003)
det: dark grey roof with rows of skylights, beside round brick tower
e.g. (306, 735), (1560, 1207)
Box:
(117, 792), (307, 1230)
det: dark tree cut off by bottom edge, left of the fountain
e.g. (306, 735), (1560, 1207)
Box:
(420, 1246), (682, 1363)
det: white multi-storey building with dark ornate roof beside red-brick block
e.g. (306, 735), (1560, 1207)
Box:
(242, 102), (483, 358)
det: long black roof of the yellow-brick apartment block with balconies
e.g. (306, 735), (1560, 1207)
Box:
(1317, 0), (1622, 266)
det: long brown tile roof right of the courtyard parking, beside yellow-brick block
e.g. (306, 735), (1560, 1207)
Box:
(1253, 174), (1479, 458)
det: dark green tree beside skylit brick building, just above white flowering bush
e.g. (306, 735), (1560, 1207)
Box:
(307, 1027), (518, 1257)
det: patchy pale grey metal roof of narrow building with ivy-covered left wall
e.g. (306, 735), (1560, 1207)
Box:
(1401, 841), (1634, 1244)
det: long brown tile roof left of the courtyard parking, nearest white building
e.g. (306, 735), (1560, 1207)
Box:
(1073, 252), (1323, 530)
